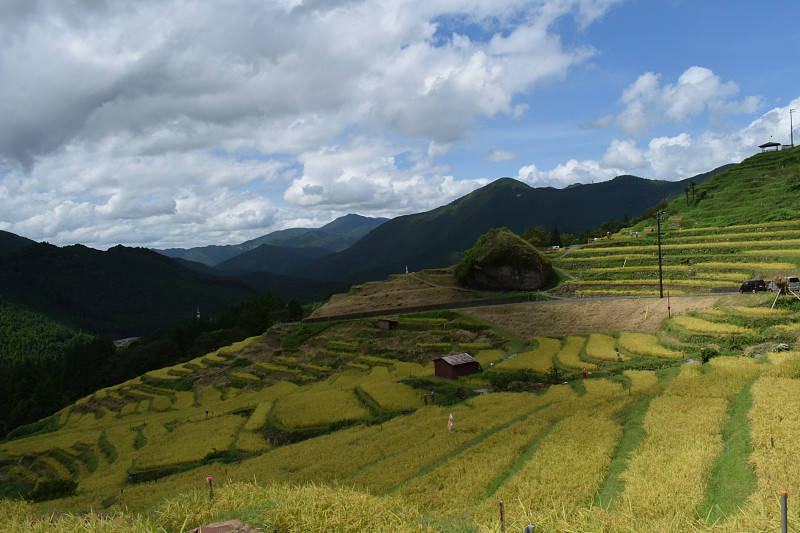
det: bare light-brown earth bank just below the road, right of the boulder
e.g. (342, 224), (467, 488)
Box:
(465, 295), (728, 338)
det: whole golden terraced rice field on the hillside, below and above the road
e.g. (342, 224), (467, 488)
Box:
(7, 196), (800, 532)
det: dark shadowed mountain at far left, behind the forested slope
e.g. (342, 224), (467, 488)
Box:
(0, 244), (332, 337)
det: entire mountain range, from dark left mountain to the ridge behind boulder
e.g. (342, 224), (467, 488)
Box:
(0, 167), (727, 337)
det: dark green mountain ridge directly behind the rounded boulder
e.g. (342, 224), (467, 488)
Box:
(298, 171), (724, 282)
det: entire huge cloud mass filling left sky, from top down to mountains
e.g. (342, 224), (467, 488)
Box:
(0, 0), (618, 247)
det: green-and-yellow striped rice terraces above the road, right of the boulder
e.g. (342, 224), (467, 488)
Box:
(553, 220), (800, 296)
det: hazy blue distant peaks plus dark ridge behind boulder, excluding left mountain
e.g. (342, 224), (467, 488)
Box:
(162, 165), (731, 283)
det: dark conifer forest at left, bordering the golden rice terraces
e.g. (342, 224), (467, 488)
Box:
(0, 296), (302, 438)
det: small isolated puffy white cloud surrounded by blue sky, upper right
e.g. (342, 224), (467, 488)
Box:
(616, 66), (761, 136)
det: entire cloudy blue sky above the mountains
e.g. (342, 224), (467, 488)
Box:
(0, 0), (800, 249)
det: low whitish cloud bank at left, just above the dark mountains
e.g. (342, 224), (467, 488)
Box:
(0, 139), (286, 247)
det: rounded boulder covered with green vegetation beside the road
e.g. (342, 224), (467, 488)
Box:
(456, 228), (552, 291)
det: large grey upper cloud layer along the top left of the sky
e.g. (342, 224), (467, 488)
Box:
(0, 0), (607, 166)
